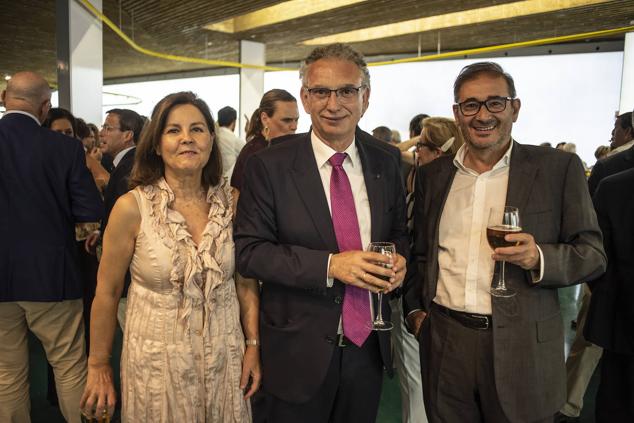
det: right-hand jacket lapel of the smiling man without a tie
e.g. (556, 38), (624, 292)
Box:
(506, 141), (537, 216)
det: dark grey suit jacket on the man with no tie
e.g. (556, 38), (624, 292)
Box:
(404, 143), (606, 422)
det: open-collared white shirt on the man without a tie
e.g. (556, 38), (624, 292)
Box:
(434, 142), (544, 314)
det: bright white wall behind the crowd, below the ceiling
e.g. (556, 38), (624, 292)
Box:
(95, 52), (623, 165)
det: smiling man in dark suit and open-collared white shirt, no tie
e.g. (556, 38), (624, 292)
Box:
(405, 63), (605, 423)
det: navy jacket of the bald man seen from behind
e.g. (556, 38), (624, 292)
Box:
(0, 113), (103, 301)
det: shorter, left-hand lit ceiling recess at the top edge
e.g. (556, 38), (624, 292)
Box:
(205, 0), (366, 34)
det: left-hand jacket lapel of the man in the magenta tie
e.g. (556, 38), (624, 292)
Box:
(291, 132), (339, 251)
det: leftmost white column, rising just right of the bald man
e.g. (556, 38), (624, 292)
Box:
(57, 0), (103, 125)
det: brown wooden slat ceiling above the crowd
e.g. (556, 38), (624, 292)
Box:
(0, 0), (634, 87)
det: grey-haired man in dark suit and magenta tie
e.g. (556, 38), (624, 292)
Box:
(235, 44), (408, 423)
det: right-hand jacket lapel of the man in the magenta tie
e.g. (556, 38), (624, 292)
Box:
(355, 131), (386, 248)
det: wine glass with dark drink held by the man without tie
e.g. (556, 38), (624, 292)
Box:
(487, 206), (522, 298)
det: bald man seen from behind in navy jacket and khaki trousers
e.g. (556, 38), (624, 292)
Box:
(0, 72), (103, 422)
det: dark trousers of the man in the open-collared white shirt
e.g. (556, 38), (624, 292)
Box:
(420, 306), (553, 423)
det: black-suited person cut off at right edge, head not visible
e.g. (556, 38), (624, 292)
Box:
(584, 167), (634, 422)
